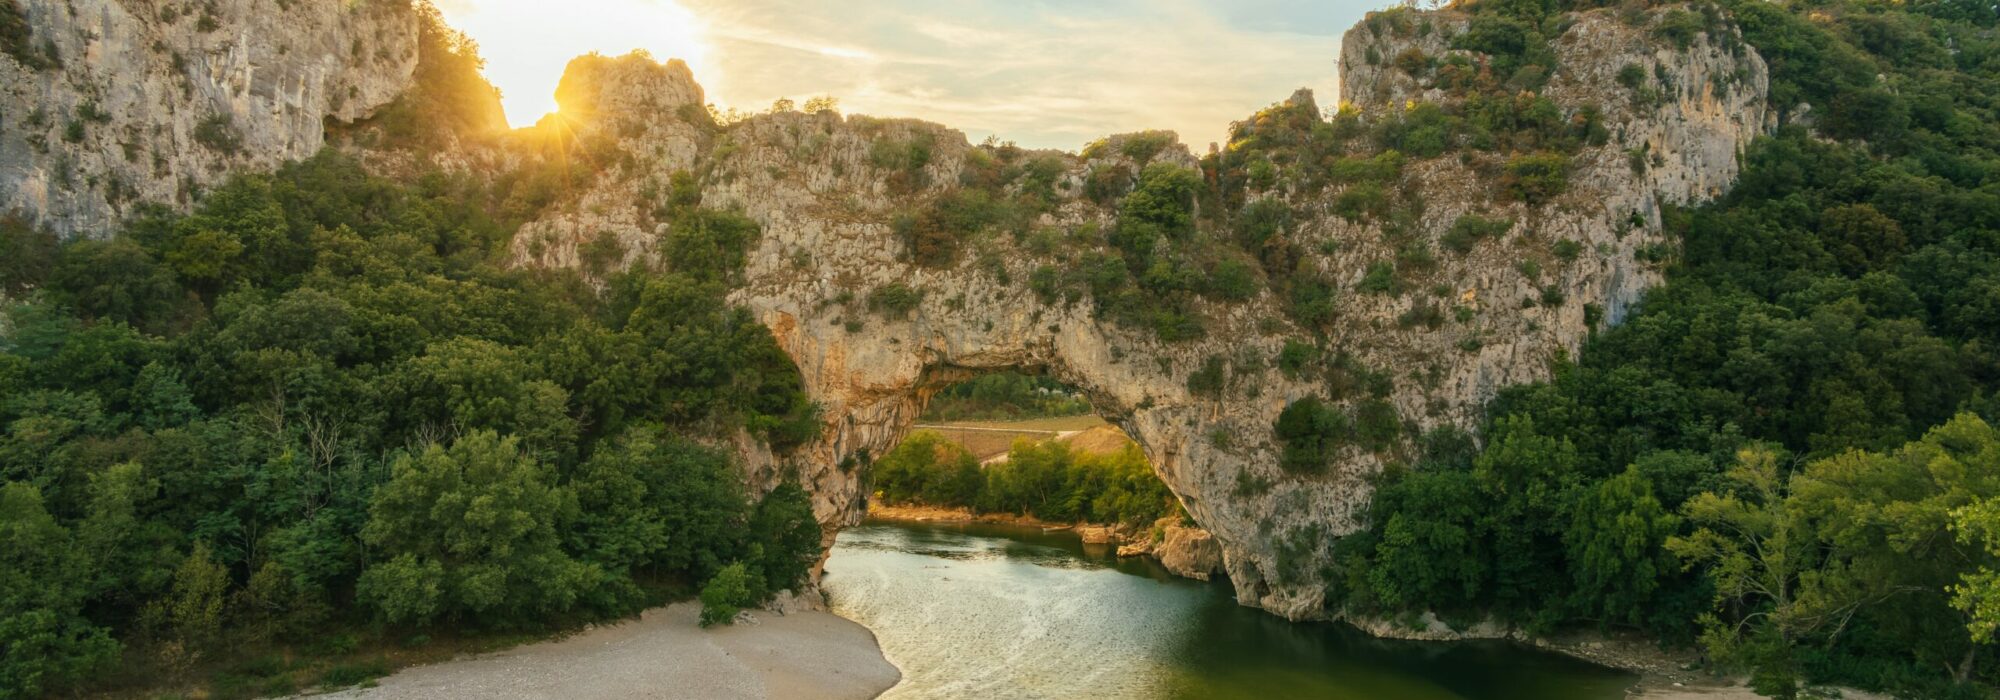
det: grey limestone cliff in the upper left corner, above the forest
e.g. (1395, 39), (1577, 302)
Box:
(0, 0), (418, 236)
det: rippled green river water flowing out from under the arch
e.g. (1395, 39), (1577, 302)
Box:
(826, 522), (1634, 700)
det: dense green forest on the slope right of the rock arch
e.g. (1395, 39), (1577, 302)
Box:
(1320, 0), (2000, 698)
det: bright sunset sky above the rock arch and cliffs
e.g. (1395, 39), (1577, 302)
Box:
(438, 0), (1388, 152)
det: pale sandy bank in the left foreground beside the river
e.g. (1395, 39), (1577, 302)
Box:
(316, 602), (902, 700)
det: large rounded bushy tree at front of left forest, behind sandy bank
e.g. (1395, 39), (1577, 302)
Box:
(356, 432), (602, 626)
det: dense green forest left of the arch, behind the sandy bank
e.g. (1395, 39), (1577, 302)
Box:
(0, 152), (820, 696)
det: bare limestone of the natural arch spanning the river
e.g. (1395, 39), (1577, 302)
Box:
(496, 10), (1768, 618)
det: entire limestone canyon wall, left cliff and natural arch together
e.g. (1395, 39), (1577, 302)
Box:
(0, 0), (1768, 618)
